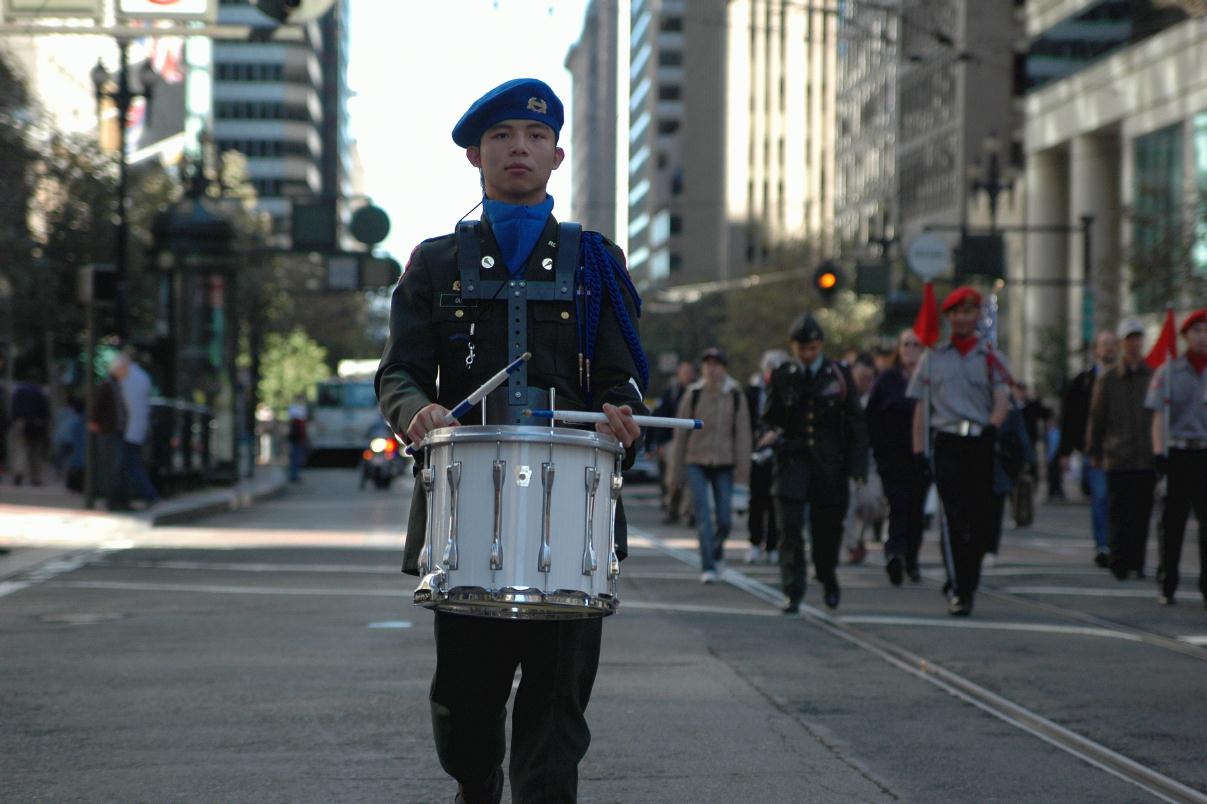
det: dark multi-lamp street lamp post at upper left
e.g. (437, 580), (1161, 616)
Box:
(91, 39), (159, 343)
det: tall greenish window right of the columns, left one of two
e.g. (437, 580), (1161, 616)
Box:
(1132, 123), (1183, 313)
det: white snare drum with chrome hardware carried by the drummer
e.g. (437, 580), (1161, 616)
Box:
(415, 425), (624, 619)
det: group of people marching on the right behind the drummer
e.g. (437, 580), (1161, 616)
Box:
(648, 294), (1207, 617)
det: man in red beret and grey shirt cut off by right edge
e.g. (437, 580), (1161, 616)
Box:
(1144, 308), (1207, 606)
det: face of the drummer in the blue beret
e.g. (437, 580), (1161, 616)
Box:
(465, 120), (566, 205)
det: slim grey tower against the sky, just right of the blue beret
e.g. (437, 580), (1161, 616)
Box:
(566, 0), (619, 239)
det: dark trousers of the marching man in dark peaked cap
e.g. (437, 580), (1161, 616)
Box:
(775, 487), (850, 602)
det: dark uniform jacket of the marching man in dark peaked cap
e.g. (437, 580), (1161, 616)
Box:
(762, 360), (868, 506)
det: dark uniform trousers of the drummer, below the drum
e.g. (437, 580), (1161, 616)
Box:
(431, 611), (604, 804)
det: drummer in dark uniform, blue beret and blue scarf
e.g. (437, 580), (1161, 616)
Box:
(377, 78), (648, 803)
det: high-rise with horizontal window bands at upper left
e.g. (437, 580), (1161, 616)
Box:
(207, 0), (349, 231)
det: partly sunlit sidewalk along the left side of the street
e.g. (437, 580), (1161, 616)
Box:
(0, 465), (285, 578)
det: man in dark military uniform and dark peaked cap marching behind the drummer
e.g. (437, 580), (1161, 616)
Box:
(759, 313), (868, 614)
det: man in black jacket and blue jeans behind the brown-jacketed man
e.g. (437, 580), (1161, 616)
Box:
(1049, 331), (1119, 567)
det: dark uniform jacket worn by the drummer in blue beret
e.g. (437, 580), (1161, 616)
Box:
(377, 216), (647, 575)
